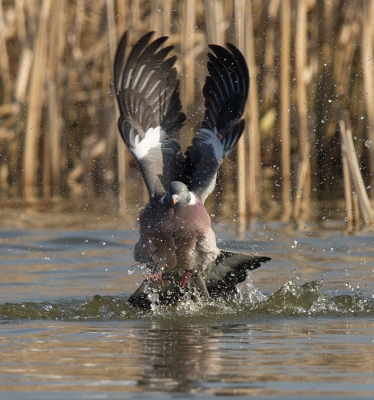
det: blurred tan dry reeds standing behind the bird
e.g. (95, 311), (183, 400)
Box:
(0, 0), (374, 230)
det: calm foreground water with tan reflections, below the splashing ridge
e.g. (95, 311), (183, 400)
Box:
(0, 318), (374, 396)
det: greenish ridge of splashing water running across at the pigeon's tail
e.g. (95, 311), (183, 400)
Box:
(0, 280), (374, 321)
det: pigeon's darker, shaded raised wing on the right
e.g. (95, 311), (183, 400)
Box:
(186, 43), (249, 203)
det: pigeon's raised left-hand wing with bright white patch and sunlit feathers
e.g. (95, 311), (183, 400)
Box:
(114, 32), (186, 197)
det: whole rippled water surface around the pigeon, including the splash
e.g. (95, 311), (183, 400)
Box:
(0, 220), (374, 399)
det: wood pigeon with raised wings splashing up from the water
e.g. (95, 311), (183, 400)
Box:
(114, 32), (270, 305)
